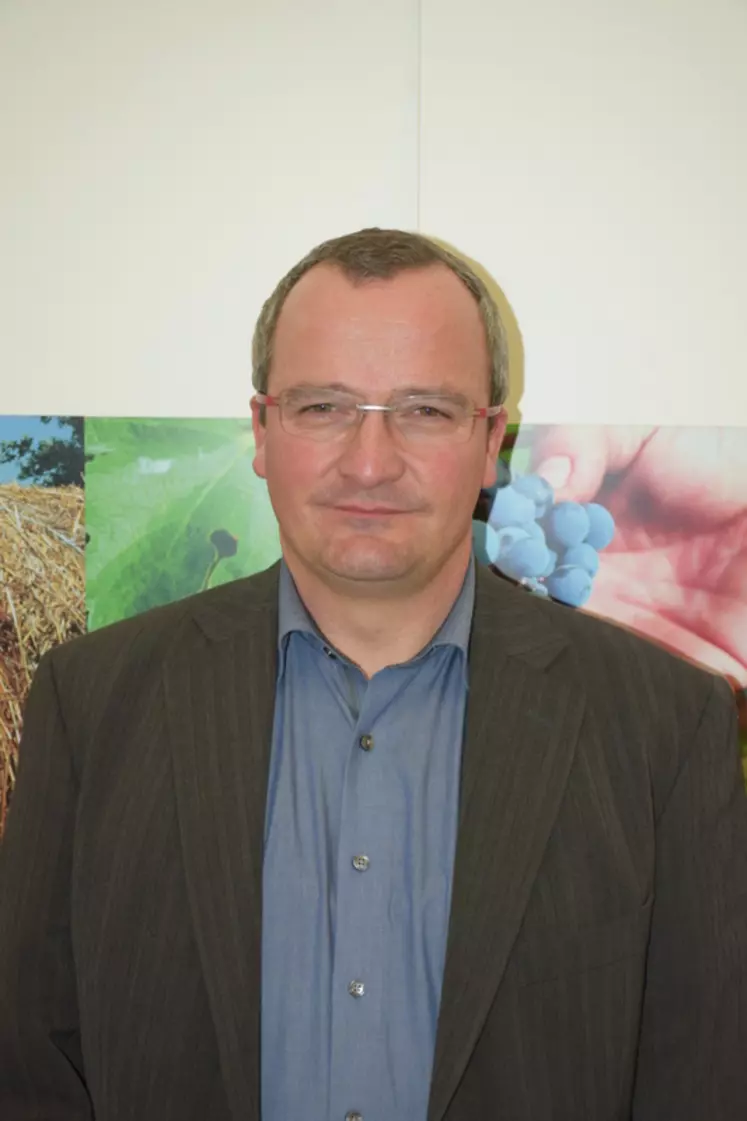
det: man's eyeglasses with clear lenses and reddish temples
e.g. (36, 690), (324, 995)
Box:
(251, 386), (504, 444)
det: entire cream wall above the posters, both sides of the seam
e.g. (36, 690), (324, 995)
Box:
(0, 0), (747, 425)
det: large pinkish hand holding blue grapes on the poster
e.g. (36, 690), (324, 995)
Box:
(527, 426), (747, 687)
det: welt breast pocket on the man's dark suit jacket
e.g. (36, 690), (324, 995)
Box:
(511, 899), (653, 986)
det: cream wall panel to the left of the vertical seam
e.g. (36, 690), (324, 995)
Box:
(0, 0), (418, 416)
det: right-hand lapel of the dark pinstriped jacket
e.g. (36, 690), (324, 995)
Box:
(427, 566), (584, 1121)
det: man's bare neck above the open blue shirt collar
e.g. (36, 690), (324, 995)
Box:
(284, 538), (472, 677)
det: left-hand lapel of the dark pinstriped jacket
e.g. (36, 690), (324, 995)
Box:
(164, 566), (277, 1121)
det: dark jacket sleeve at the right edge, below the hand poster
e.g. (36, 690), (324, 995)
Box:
(633, 677), (747, 1121)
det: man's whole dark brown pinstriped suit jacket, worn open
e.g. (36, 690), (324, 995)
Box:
(0, 566), (747, 1121)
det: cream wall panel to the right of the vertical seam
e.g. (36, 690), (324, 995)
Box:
(419, 0), (747, 425)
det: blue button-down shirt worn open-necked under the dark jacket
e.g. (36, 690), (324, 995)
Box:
(261, 561), (474, 1121)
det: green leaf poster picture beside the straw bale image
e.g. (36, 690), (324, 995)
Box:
(85, 418), (280, 630)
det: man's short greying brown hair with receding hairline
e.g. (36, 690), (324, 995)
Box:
(251, 226), (508, 405)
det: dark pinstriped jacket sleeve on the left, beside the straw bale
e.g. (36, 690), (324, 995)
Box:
(0, 651), (93, 1121)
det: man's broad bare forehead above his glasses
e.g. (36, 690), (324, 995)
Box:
(273, 263), (488, 373)
